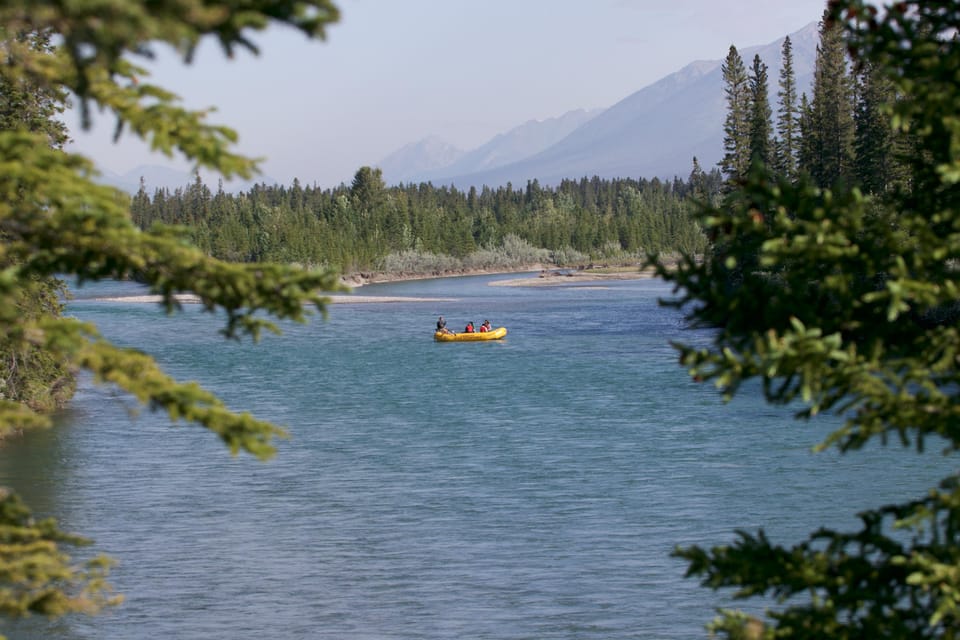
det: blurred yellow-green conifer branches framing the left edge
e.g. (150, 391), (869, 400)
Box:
(0, 0), (339, 628)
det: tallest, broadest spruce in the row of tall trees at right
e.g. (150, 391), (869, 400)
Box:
(804, 8), (855, 187)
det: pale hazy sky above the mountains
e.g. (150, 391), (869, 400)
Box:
(68, 0), (826, 187)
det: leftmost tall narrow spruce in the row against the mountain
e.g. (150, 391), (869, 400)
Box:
(719, 45), (750, 185)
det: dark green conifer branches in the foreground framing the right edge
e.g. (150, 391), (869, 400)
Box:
(658, 0), (960, 639)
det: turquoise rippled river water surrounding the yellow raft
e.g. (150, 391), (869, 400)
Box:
(0, 275), (948, 640)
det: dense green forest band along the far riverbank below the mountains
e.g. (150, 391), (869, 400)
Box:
(131, 167), (722, 273)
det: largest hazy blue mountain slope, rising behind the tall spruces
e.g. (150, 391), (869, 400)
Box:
(390, 22), (819, 188)
